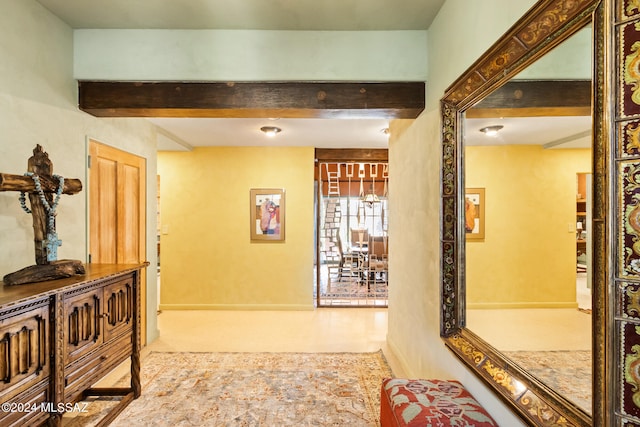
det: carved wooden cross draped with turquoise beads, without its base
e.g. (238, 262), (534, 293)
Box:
(0, 144), (82, 265)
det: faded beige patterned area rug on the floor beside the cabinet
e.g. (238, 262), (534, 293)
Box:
(67, 351), (393, 427)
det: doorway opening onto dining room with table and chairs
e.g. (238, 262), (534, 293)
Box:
(315, 161), (389, 307)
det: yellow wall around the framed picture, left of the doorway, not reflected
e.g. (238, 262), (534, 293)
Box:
(158, 147), (314, 310)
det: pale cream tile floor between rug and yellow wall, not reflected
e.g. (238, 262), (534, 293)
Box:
(99, 308), (406, 386)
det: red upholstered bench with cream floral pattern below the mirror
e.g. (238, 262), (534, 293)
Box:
(380, 378), (498, 427)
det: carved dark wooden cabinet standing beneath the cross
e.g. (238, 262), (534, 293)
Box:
(0, 264), (145, 426)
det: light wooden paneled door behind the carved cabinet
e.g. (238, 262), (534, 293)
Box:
(89, 141), (147, 343)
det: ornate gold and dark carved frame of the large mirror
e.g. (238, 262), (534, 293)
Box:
(440, 0), (609, 426)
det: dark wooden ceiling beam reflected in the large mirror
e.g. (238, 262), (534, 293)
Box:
(466, 80), (591, 118)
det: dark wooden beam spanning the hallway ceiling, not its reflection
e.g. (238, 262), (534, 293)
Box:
(78, 81), (425, 119)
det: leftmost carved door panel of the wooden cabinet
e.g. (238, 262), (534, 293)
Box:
(0, 300), (50, 401)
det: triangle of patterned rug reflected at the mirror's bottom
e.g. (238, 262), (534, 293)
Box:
(504, 351), (592, 413)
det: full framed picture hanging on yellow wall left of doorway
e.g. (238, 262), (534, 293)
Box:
(249, 188), (285, 242)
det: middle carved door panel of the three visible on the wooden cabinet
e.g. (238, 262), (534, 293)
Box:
(64, 289), (102, 364)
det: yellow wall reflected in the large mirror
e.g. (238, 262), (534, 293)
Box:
(465, 145), (591, 308)
